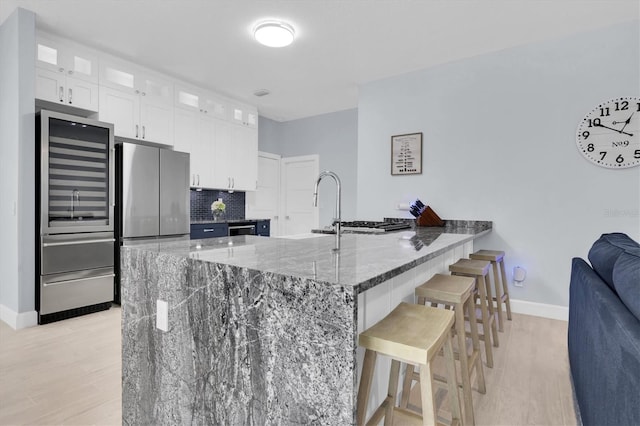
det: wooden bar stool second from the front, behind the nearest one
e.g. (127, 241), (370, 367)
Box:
(400, 274), (487, 424)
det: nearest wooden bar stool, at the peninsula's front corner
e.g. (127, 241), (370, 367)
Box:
(357, 302), (462, 425)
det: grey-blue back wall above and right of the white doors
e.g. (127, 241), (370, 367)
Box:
(258, 109), (360, 226)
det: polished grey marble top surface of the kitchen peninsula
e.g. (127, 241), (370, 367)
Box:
(126, 221), (492, 294)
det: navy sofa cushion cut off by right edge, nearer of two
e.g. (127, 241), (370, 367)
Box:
(613, 248), (640, 319)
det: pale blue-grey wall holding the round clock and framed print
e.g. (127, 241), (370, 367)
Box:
(357, 21), (640, 306)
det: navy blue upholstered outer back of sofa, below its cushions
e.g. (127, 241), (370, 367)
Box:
(568, 258), (640, 425)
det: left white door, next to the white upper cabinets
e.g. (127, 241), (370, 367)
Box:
(245, 152), (282, 237)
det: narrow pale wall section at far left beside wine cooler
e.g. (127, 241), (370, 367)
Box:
(0, 9), (36, 328)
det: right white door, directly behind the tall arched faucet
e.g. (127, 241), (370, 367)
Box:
(281, 155), (320, 235)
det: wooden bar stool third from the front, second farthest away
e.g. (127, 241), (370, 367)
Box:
(449, 259), (500, 368)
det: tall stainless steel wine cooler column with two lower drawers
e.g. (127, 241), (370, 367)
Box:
(35, 110), (115, 324)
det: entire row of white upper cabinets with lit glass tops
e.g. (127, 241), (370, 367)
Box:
(35, 32), (258, 186)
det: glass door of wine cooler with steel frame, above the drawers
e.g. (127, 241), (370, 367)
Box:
(37, 111), (114, 234)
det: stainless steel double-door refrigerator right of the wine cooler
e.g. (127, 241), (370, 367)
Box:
(114, 142), (190, 303)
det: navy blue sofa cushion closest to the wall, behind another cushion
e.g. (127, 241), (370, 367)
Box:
(589, 232), (640, 291)
